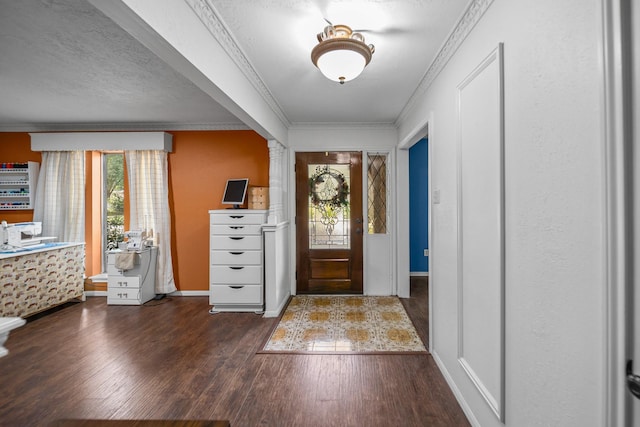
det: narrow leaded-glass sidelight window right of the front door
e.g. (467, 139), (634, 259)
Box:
(367, 153), (387, 234)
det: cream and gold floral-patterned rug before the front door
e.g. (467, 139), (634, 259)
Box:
(259, 295), (427, 354)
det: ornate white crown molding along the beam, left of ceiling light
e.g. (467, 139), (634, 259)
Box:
(185, 0), (291, 127)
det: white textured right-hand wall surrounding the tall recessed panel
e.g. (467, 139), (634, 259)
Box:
(399, 0), (605, 427)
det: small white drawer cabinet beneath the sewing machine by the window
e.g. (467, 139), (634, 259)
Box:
(107, 246), (158, 305)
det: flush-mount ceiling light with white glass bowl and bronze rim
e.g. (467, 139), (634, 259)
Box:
(311, 25), (375, 84)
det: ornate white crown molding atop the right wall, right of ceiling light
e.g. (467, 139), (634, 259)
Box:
(396, 0), (493, 125)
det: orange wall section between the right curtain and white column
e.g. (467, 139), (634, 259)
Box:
(169, 131), (269, 291)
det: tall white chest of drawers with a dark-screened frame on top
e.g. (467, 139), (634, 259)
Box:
(209, 209), (268, 313)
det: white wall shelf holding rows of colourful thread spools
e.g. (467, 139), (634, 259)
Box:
(0, 162), (40, 210)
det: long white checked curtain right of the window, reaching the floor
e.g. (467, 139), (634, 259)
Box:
(125, 150), (176, 294)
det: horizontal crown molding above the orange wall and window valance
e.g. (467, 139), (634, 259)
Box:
(0, 122), (251, 132)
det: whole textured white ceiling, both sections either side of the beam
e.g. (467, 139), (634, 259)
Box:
(0, 0), (469, 130)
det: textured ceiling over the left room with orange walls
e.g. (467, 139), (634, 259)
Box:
(0, 0), (240, 129)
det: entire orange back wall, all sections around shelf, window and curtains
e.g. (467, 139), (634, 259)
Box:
(0, 131), (269, 291)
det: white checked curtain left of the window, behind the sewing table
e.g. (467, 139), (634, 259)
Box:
(33, 151), (85, 242)
